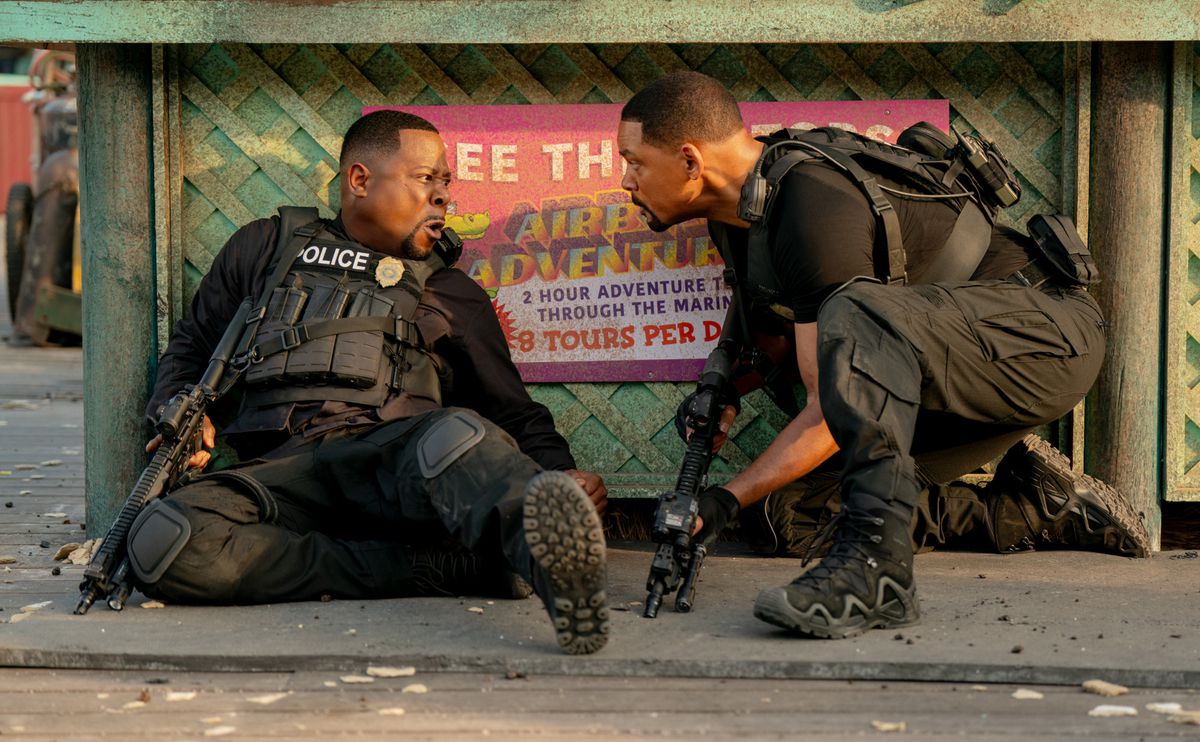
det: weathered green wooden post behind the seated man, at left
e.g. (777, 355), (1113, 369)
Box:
(77, 43), (156, 535)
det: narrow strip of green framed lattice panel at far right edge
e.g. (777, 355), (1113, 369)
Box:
(1165, 43), (1200, 501)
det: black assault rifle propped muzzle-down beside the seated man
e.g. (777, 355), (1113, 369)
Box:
(74, 299), (260, 616)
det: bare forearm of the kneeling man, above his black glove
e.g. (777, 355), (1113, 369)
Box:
(725, 395), (838, 507)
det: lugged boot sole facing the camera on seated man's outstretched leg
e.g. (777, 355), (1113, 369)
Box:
(524, 472), (608, 654)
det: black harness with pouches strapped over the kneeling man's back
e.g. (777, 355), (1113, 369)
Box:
(709, 122), (1021, 319)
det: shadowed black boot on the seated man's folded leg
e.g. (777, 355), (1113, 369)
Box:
(409, 546), (533, 600)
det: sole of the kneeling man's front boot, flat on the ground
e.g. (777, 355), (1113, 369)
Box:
(754, 578), (920, 639)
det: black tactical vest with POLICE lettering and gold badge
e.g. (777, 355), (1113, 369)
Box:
(242, 207), (462, 408)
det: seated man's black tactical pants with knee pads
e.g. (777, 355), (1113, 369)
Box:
(140, 408), (541, 604)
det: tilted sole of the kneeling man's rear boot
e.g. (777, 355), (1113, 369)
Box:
(1021, 435), (1150, 558)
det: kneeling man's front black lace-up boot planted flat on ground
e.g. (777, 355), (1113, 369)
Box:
(754, 503), (920, 639)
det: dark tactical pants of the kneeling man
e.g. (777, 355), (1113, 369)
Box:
(753, 281), (1104, 549)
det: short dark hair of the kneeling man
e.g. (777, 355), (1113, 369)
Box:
(620, 71), (745, 148)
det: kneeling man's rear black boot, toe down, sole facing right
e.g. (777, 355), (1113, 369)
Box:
(986, 435), (1150, 557)
